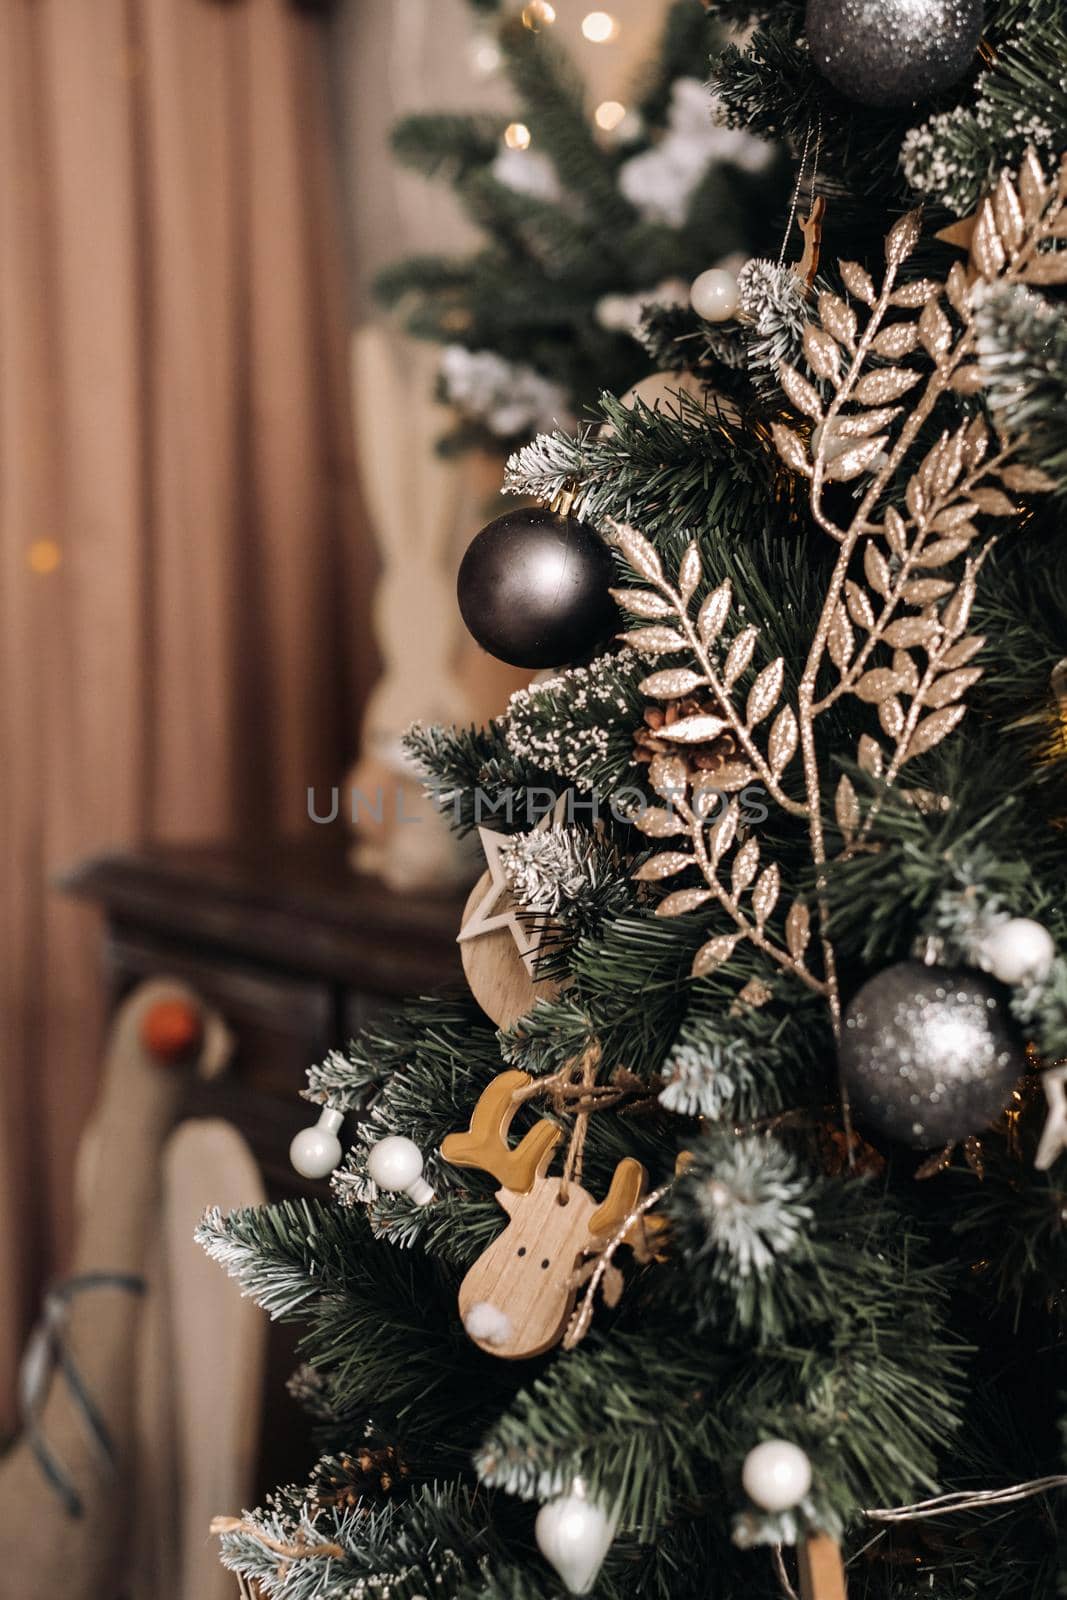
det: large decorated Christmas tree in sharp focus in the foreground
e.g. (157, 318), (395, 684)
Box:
(202, 0), (1067, 1600)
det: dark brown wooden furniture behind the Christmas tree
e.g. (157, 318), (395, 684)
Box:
(58, 827), (462, 1488)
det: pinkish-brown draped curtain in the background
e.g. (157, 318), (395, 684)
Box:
(0, 0), (370, 1427)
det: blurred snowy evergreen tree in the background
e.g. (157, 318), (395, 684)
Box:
(378, 0), (789, 453)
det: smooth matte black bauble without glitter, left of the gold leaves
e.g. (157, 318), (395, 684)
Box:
(458, 506), (617, 667)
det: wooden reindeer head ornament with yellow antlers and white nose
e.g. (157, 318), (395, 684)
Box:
(442, 1072), (648, 1360)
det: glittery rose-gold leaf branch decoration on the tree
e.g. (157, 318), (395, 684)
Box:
(608, 154), (1067, 1049)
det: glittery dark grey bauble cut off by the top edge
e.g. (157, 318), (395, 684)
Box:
(805, 0), (982, 106)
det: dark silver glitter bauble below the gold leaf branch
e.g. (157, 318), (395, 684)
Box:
(840, 962), (1025, 1150)
